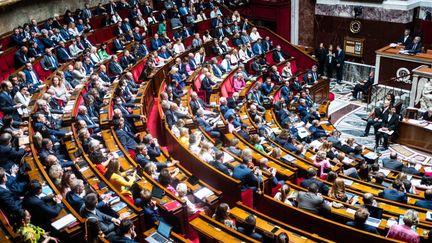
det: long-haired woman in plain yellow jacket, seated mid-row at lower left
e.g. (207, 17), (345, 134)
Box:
(105, 158), (137, 199)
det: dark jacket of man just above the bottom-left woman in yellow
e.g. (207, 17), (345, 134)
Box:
(23, 196), (62, 227)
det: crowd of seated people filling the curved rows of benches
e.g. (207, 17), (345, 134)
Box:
(0, 1), (428, 242)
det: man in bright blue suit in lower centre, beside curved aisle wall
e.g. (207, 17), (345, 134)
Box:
(232, 159), (262, 192)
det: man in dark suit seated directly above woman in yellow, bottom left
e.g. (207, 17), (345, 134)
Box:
(23, 180), (63, 229)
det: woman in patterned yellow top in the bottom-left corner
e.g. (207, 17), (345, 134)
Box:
(17, 210), (58, 243)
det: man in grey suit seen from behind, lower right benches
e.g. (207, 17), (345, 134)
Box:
(296, 183), (331, 215)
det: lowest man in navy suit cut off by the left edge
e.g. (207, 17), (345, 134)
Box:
(0, 167), (22, 218)
